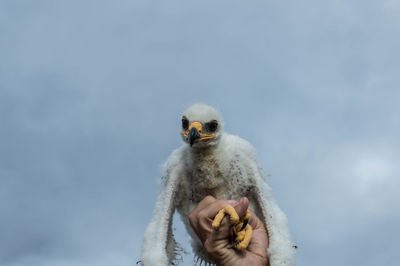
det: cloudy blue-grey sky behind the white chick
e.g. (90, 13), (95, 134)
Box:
(0, 0), (400, 266)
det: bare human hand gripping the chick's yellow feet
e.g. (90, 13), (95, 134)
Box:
(189, 196), (269, 266)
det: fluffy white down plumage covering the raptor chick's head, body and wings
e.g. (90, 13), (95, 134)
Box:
(141, 104), (295, 266)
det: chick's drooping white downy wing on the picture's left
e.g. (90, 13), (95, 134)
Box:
(141, 150), (184, 266)
